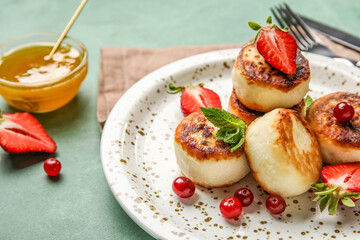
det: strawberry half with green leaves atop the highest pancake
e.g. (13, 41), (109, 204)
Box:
(249, 16), (297, 74)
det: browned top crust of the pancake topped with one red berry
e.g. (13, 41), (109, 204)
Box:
(307, 92), (360, 149)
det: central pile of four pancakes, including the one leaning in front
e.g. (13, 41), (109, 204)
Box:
(174, 45), (322, 196)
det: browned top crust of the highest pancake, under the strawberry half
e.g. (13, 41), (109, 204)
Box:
(235, 45), (310, 92)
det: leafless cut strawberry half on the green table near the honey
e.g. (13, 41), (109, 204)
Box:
(0, 112), (56, 153)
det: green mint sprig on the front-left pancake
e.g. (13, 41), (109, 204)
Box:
(200, 107), (246, 152)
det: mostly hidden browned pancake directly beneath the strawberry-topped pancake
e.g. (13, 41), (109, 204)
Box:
(229, 90), (305, 125)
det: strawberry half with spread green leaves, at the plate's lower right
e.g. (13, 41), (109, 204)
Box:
(311, 162), (360, 215)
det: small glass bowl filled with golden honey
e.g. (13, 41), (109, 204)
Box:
(0, 33), (88, 113)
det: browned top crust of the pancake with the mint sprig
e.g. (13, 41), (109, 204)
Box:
(175, 112), (243, 161)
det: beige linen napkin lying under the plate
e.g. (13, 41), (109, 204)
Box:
(97, 36), (360, 128)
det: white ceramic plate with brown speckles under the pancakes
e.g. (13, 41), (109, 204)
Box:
(101, 49), (360, 240)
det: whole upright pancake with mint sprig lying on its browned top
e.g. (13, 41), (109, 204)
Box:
(174, 113), (249, 187)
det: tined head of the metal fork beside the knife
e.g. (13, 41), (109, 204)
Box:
(270, 3), (337, 58)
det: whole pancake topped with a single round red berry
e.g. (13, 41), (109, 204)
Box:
(307, 92), (360, 164)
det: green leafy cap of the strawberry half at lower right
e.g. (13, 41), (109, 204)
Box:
(311, 183), (360, 215)
